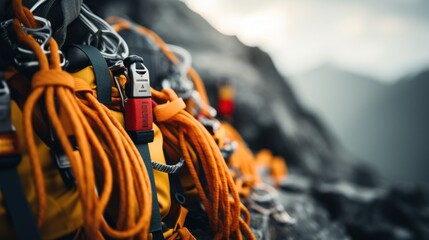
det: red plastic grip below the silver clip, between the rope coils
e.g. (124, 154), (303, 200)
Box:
(125, 98), (153, 131)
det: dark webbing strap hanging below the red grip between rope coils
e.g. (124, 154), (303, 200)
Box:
(130, 131), (164, 240)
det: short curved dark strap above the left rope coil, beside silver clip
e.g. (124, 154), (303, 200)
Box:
(72, 44), (112, 105)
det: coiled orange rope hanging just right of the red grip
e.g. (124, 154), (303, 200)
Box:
(152, 89), (254, 239)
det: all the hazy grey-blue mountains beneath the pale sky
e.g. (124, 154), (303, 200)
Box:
(291, 64), (429, 184)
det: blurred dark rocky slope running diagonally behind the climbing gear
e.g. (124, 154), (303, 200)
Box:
(84, 0), (429, 239)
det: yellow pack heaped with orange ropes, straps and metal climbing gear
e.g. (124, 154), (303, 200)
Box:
(0, 0), (288, 239)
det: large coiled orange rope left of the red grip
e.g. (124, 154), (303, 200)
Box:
(13, 0), (152, 239)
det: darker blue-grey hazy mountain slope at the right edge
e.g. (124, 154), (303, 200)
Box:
(350, 68), (429, 184)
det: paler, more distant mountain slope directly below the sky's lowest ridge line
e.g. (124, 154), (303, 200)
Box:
(292, 64), (385, 143)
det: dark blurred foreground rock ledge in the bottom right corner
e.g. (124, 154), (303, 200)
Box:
(278, 174), (429, 240)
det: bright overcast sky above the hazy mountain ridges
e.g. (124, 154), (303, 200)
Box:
(185, 0), (429, 82)
